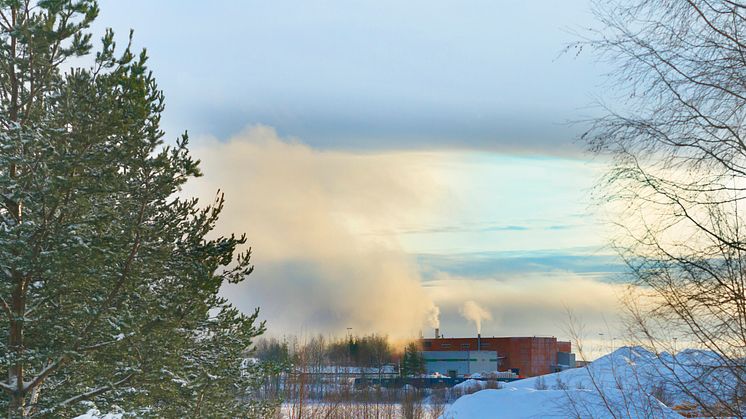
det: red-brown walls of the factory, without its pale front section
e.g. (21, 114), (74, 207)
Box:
(420, 336), (574, 377)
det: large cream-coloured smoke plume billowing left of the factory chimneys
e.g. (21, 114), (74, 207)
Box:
(185, 127), (438, 338)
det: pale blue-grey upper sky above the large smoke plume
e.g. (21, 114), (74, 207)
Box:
(97, 0), (600, 152)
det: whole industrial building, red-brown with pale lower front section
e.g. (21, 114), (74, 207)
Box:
(420, 329), (575, 377)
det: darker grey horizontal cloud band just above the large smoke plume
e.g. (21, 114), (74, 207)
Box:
(190, 107), (587, 158)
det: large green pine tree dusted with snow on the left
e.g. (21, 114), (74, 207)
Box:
(0, 0), (264, 417)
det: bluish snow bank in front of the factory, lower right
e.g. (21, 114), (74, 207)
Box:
(442, 347), (735, 419)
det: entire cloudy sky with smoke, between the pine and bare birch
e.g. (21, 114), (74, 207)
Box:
(94, 0), (619, 346)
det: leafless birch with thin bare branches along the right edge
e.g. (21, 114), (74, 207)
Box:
(576, 0), (746, 416)
